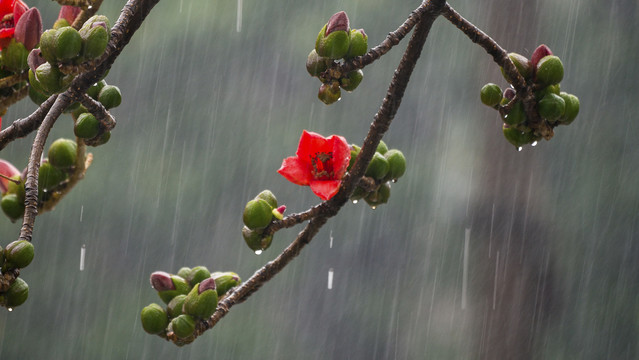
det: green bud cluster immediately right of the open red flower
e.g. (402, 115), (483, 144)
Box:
(348, 141), (406, 209)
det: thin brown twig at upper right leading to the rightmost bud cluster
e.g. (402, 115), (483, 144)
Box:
(442, 3), (553, 140)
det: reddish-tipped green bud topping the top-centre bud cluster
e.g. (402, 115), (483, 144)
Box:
(315, 11), (351, 59)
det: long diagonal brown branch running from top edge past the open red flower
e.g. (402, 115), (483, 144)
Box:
(160, 0), (445, 345)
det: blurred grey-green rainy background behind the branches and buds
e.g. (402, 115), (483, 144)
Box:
(0, 0), (639, 360)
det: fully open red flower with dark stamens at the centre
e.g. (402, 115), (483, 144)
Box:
(277, 130), (351, 200)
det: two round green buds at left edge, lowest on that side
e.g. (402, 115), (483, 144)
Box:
(0, 240), (34, 309)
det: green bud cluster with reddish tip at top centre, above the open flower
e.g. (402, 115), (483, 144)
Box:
(306, 11), (368, 105)
